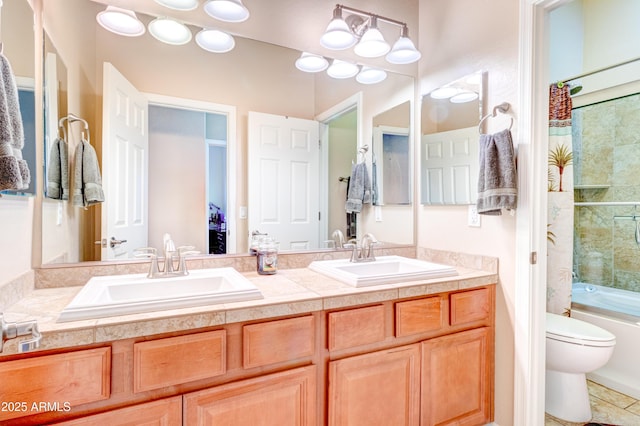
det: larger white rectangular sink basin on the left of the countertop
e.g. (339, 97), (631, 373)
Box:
(58, 268), (263, 322)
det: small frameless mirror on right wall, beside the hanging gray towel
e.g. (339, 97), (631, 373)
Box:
(420, 72), (484, 205)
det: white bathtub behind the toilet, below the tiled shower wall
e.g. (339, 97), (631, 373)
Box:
(571, 283), (640, 399)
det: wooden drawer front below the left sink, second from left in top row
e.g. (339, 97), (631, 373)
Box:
(133, 330), (227, 392)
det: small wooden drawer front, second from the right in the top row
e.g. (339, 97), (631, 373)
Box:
(396, 296), (444, 337)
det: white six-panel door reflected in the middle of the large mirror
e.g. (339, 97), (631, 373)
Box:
(248, 112), (320, 250)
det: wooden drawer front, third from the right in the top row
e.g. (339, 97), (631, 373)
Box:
(328, 305), (384, 351)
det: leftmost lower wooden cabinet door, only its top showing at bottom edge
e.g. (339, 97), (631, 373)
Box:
(56, 396), (182, 426)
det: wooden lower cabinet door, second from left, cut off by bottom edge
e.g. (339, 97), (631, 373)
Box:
(183, 365), (317, 426)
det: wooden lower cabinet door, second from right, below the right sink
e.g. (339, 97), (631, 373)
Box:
(328, 344), (420, 426)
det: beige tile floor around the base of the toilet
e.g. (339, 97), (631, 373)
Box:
(545, 381), (640, 426)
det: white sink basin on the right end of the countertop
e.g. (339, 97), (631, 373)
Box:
(309, 256), (458, 287)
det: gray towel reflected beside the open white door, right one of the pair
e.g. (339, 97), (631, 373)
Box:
(73, 140), (104, 208)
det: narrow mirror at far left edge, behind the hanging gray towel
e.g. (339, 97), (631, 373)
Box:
(0, 0), (37, 195)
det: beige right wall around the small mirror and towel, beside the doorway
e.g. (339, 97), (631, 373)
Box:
(418, 0), (519, 426)
